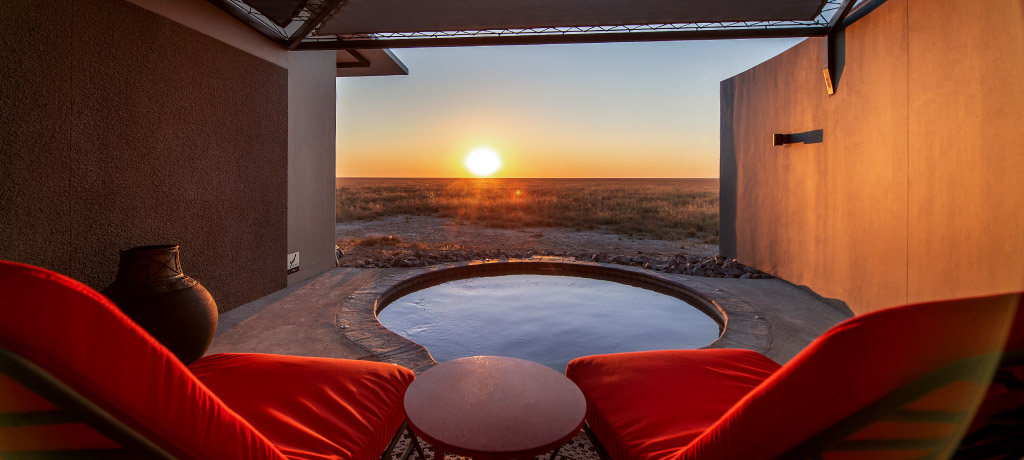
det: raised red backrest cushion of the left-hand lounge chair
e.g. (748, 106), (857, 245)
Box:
(0, 261), (285, 460)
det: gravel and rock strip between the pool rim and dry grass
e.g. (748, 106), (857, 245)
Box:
(335, 216), (771, 279)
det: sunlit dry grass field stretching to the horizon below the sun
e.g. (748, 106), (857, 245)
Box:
(335, 177), (718, 244)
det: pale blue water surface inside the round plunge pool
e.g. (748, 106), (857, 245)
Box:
(378, 275), (720, 371)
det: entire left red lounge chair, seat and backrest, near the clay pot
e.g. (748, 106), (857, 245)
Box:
(0, 261), (413, 460)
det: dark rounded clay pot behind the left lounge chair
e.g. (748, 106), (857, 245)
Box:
(101, 241), (217, 365)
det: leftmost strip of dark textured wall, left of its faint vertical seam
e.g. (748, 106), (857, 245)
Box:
(0, 0), (73, 273)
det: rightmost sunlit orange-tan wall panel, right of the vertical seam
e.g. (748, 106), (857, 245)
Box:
(907, 0), (1024, 299)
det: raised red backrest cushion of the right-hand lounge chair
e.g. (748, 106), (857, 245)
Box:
(680, 295), (1020, 459)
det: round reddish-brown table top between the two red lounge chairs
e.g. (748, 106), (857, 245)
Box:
(406, 357), (587, 458)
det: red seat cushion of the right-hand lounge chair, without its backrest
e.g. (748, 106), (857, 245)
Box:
(565, 349), (779, 460)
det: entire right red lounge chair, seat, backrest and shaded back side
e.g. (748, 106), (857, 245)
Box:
(565, 295), (1024, 460)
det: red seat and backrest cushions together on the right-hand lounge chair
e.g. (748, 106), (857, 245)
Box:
(566, 294), (1020, 460)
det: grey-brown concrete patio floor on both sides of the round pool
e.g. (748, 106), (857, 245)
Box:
(207, 267), (851, 373)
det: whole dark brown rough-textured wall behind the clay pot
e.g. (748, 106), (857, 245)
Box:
(0, 0), (288, 310)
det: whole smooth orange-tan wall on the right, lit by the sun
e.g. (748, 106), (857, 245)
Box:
(721, 0), (1024, 313)
